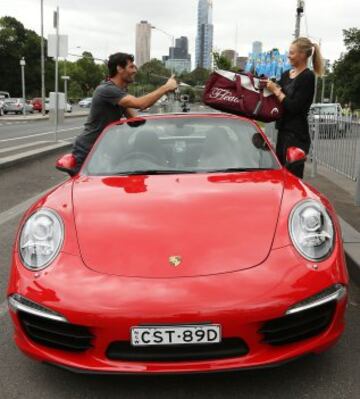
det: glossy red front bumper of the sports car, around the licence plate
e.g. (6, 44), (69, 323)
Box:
(9, 247), (347, 373)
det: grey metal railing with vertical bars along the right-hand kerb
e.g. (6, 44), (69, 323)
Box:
(265, 115), (360, 206)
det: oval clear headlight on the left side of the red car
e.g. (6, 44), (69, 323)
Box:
(19, 208), (64, 271)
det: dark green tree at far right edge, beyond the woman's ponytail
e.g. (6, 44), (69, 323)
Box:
(334, 28), (360, 109)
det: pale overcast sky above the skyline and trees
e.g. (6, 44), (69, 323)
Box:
(0, 0), (360, 66)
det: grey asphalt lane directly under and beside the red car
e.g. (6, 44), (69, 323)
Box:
(0, 148), (360, 399)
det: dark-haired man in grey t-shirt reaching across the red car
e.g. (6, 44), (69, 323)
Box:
(72, 53), (177, 170)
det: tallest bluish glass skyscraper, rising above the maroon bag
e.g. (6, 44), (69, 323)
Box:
(195, 0), (214, 69)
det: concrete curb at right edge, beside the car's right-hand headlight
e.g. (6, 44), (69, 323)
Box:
(339, 217), (360, 285)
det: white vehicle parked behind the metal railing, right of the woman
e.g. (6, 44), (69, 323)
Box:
(309, 103), (346, 139)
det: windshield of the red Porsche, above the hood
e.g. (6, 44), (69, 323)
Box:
(84, 117), (279, 175)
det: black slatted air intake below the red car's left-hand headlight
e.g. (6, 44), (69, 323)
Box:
(18, 311), (94, 352)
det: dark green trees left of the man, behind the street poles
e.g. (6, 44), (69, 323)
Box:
(0, 17), (107, 98)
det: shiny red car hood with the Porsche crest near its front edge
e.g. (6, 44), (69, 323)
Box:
(73, 170), (284, 278)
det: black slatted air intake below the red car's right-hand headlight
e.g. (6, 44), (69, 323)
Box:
(259, 301), (336, 345)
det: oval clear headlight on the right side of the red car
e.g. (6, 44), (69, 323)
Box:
(289, 200), (335, 261)
